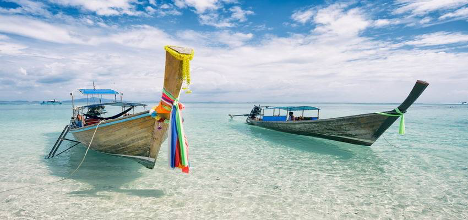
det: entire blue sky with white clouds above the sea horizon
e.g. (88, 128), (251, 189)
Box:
(0, 0), (468, 103)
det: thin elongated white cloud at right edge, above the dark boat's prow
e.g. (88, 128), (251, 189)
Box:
(406, 32), (468, 46)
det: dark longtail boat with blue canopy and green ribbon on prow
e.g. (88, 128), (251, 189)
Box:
(229, 80), (429, 146)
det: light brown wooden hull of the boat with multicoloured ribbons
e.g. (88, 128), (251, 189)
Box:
(70, 111), (166, 168)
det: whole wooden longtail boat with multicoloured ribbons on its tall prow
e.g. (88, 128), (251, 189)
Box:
(47, 46), (193, 172)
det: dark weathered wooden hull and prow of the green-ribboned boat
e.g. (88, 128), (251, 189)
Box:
(247, 80), (429, 146)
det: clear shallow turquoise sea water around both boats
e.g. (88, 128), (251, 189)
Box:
(0, 103), (468, 219)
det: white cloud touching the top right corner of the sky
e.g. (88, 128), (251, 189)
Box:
(395, 0), (468, 15)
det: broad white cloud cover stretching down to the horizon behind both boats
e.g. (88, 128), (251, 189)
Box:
(0, 1), (468, 102)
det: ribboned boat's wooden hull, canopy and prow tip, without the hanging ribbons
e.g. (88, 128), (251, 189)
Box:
(48, 46), (193, 169)
